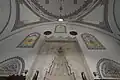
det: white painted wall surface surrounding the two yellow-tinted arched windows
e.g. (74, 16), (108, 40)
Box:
(0, 24), (120, 78)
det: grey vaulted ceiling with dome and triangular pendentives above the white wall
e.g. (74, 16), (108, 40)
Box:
(0, 0), (120, 38)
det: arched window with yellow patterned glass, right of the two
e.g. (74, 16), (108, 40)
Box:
(81, 33), (106, 50)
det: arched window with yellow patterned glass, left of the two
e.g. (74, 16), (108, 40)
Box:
(17, 32), (40, 48)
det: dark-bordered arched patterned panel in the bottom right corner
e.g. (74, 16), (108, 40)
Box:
(97, 58), (120, 79)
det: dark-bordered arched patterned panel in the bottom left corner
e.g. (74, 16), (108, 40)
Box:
(0, 56), (25, 76)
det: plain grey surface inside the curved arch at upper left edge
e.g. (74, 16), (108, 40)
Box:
(0, 0), (12, 34)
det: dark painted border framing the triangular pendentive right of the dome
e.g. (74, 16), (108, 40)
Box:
(72, 0), (113, 33)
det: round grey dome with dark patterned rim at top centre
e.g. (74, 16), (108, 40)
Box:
(24, 0), (99, 20)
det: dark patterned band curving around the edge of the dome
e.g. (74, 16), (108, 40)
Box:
(23, 0), (101, 21)
